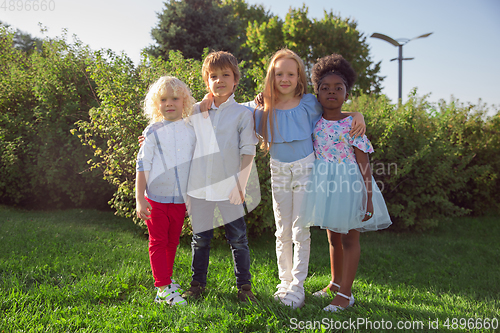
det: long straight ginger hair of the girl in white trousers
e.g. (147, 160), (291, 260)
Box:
(254, 49), (307, 153)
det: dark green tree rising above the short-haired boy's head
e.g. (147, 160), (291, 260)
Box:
(148, 0), (240, 59)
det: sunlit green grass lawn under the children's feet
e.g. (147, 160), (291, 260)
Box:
(0, 207), (500, 333)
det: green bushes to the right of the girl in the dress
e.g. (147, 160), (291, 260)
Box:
(349, 91), (499, 230)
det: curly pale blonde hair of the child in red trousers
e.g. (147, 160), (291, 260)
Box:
(144, 76), (196, 123)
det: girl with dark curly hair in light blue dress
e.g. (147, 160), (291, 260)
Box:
(301, 54), (391, 312)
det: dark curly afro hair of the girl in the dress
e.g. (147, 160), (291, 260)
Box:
(311, 53), (356, 94)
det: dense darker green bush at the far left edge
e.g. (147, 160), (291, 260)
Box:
(0, 27), (111, 209)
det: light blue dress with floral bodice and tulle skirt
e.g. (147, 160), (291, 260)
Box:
(300, 116), (392, 234)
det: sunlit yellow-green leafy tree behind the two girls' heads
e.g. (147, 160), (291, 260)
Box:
(245, 5), (383, 94)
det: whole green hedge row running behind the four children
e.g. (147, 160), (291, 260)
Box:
(0, 30), (500, 235)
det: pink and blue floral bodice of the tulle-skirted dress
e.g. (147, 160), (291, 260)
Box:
(313, 116), (374, 163)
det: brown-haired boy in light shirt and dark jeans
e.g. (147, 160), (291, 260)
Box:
(183, 51), (258, 302)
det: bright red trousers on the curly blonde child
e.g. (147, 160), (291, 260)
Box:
(146, 198), (186, 287)
